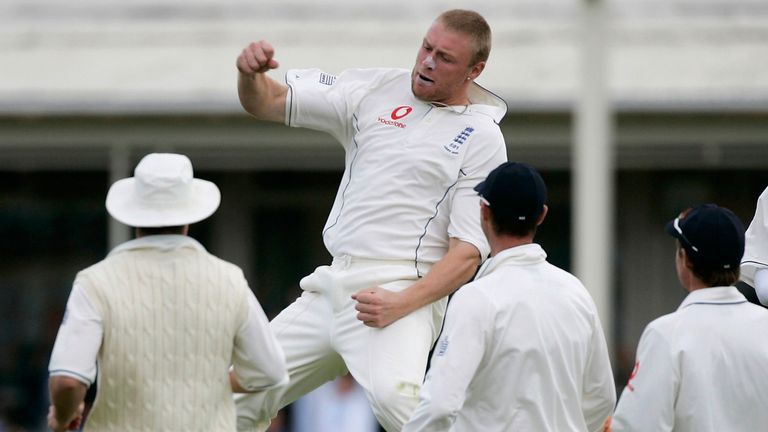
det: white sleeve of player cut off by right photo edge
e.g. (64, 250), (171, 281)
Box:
(741, 187), (768, 286)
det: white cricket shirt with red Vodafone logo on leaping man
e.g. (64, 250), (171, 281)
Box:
(286, 69), (507, 263)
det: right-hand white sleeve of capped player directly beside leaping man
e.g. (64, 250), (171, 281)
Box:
(581, 314), (616, 431)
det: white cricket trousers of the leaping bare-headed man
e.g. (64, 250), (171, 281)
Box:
(236, 257), (447, 432)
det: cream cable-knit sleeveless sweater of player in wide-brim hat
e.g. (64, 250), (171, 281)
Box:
(78, 241), (249, 432)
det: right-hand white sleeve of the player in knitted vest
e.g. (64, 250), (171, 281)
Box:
(232, 290), (288, 391)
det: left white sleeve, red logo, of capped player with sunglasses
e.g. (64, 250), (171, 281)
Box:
(611, 323), (680, 432)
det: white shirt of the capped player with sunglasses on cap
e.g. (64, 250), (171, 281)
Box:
(612, 287), (768, 432)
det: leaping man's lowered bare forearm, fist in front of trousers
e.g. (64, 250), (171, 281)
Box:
(352, 238), (480, 328)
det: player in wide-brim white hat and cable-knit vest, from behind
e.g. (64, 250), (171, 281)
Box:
(48, 153), (288, 432)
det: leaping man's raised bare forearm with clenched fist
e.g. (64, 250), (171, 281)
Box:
(237, 40), (288, 123)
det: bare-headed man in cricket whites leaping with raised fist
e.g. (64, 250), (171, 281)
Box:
(237, 10), (506, 431)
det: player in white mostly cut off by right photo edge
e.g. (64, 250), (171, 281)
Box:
(741, 187), (768, 307)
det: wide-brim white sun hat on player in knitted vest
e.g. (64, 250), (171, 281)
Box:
(106, 153), (221, 228)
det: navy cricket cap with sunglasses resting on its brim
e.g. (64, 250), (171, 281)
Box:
(666, 204), (744, 270)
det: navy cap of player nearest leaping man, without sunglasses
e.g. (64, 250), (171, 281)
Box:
(475, 162), (547, 222)
